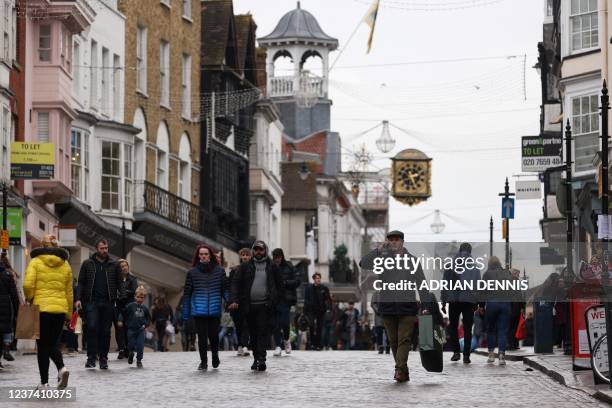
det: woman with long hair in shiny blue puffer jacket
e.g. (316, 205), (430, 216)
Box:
(183, 245), (229, 370)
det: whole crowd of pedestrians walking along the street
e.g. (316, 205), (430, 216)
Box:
(0, 231), (548, 388)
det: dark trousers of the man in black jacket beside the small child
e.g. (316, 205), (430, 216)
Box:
(85, 302), (114, 360)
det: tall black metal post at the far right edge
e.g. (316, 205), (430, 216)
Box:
(601, 79), (612, 388)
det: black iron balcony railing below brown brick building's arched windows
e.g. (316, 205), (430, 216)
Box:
(135, 181), (202, 233)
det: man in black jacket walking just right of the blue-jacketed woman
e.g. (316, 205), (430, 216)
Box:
(229, 241), (283, 371)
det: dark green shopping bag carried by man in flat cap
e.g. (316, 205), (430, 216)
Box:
(419, 315), (446, 373)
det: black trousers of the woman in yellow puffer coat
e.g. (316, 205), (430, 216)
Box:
(36, 312), (66, 384)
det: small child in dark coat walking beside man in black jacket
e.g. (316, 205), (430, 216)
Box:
(119, 286), (151, 368)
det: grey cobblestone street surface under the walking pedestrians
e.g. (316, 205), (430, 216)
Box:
(0, 351), (607, 408)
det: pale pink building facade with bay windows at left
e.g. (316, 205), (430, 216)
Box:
(23, 0), (95, 248)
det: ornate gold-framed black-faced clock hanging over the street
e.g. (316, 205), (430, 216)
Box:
(391, 149), (431, 206)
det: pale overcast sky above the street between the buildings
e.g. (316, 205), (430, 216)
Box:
(234, 0), (544, 242)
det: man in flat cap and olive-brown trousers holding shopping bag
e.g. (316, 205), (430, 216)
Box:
(360, 231), (434, 382)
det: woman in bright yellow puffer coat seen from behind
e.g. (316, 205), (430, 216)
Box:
(23, 235), (73, 388)
